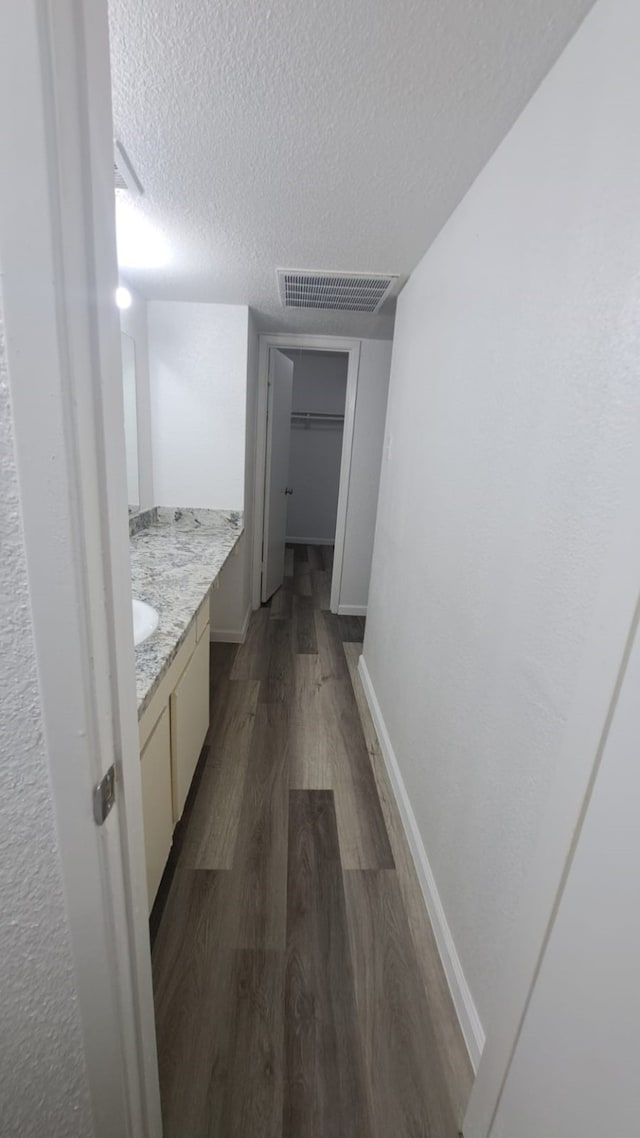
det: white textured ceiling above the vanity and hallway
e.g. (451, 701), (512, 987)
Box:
(109, 0), (593, 337)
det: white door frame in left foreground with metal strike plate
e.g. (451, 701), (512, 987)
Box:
(0, 0), (162, 1138)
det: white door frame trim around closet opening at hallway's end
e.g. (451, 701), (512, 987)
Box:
(252, 332), (361, 612)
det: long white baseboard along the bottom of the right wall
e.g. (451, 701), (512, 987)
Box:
(358, 655), (485, 1072)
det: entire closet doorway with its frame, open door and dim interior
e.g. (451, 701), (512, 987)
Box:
(254, 335), (360, 612)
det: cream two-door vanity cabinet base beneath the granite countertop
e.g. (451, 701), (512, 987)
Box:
(139, 596), (210, 912)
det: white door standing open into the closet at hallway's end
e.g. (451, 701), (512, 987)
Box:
(262, 348), (294, 602)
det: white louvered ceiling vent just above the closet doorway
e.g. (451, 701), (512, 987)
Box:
(278, 269), (397, 312)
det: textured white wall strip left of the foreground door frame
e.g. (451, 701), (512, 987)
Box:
(0, 308), (93, 1138)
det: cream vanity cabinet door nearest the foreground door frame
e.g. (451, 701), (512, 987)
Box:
(140, 707), (173, 913)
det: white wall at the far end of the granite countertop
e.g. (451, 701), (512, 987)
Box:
(148, 300), (257, 641)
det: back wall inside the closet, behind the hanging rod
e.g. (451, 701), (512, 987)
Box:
(284, 351), (348, 544)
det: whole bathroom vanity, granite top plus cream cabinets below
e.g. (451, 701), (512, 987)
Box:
(131, 509), (243, 910)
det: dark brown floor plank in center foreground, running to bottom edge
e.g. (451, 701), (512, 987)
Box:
(282, 791), (371, 1138)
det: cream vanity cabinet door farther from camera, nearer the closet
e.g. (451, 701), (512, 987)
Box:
(171, 636), (208, 822)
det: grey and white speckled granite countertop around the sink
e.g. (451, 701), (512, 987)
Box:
(130, 506), (244, 718)
